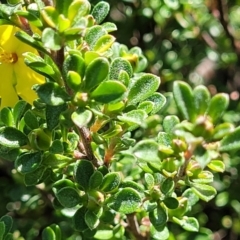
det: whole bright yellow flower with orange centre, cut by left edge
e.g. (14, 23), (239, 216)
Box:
(0, 25), (44, 108)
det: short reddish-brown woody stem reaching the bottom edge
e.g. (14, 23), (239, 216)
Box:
(127, 213), (149, 240)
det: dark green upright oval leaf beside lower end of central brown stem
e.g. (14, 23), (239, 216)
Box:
(74, 160), (94, 189)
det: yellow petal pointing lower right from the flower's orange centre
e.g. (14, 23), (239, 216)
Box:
(14, 59), (45, 104)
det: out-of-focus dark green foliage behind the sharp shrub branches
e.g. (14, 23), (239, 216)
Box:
(0, 0), (240, 240)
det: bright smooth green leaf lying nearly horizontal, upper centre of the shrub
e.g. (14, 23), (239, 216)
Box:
(90, 80), (126, 103)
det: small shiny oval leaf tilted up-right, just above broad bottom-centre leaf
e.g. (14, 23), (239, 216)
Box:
(100, 172), (121, 193)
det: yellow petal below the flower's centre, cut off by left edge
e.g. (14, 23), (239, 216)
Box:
(0, 64), (18, 108)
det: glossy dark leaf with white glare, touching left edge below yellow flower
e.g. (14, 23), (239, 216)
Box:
(0, 127), (28, 148)
